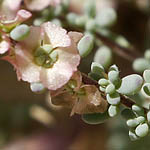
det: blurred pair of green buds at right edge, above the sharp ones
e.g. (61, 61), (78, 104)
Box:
(132, 49), (150, 73)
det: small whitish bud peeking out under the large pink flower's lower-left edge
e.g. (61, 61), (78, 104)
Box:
(30, 82), (45, 93)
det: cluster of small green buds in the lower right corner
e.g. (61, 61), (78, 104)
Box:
(121, 105), (150, 141)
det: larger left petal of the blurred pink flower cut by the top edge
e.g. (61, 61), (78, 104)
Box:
(24, 0), (51, 11)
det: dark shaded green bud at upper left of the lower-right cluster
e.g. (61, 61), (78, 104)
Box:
(121, 108), (136, 120)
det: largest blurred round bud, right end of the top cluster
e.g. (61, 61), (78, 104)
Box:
(96, 7), (117, 27)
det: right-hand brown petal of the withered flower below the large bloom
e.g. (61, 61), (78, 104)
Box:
(71, 85), (108, 115)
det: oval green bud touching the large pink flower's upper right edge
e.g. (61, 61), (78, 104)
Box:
(78, 35), (94, 57)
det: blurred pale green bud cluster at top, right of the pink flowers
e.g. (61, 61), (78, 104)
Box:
(67, 0), (117, 32)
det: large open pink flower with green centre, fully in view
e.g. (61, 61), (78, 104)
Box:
(4, 22), (82, 90)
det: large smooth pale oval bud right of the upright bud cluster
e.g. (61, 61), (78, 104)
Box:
(117, 74), (143, 95)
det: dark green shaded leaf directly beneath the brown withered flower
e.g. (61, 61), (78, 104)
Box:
(82, 111), (109, 124)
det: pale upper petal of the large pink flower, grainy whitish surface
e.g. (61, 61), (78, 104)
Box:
(42, 22), (71, 48)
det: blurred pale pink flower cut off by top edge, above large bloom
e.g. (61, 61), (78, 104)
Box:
(24, 0), (61, 11)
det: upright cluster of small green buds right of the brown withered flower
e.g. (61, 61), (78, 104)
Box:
(98, 65), (121, 117)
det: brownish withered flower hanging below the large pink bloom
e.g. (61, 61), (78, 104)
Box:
(50, 71), (108, 115)
